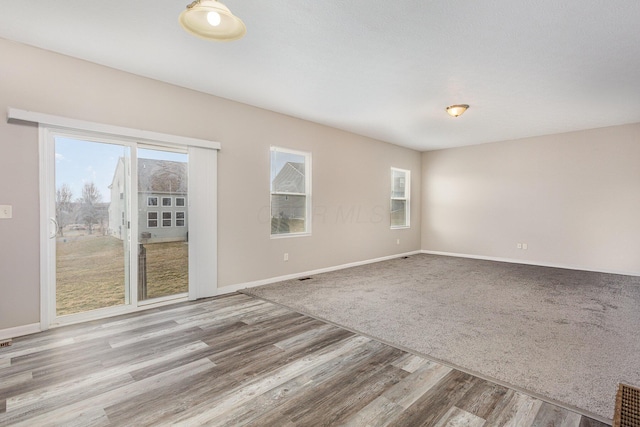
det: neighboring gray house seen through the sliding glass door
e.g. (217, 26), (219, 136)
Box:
(109, 158), (188, 243)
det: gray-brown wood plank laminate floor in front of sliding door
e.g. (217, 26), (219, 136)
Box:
(0, 294), (605, 427)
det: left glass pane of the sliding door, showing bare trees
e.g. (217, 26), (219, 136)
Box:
(51, 136), (130, 316)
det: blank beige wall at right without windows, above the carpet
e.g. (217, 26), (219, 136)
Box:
(422, 124), (640, 274)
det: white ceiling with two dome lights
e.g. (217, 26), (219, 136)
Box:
(0, 0), (640, 150)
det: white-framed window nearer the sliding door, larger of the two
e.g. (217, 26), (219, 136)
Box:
(271, 147), (311, 237)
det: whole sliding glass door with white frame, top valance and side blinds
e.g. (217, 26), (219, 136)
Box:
(33, 115), (220, 330)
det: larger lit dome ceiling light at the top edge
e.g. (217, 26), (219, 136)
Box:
(180, 0), (247, 42)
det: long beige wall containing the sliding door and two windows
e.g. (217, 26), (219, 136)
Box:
(0, 39), (421, 330)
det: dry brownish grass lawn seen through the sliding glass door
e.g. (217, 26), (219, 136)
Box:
(56, 235), (189, 315)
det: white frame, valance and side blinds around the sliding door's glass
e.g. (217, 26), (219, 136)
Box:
(7, 108), (221, 330)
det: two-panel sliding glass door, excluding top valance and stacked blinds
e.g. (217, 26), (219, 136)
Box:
(43, 131), (189, 323)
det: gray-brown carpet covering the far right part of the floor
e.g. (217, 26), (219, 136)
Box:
(244, 255), (640, 419)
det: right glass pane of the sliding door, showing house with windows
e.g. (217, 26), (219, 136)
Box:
(138, 148), (189, 301)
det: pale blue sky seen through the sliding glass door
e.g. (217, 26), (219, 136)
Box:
(55, 137), (187, 203)
